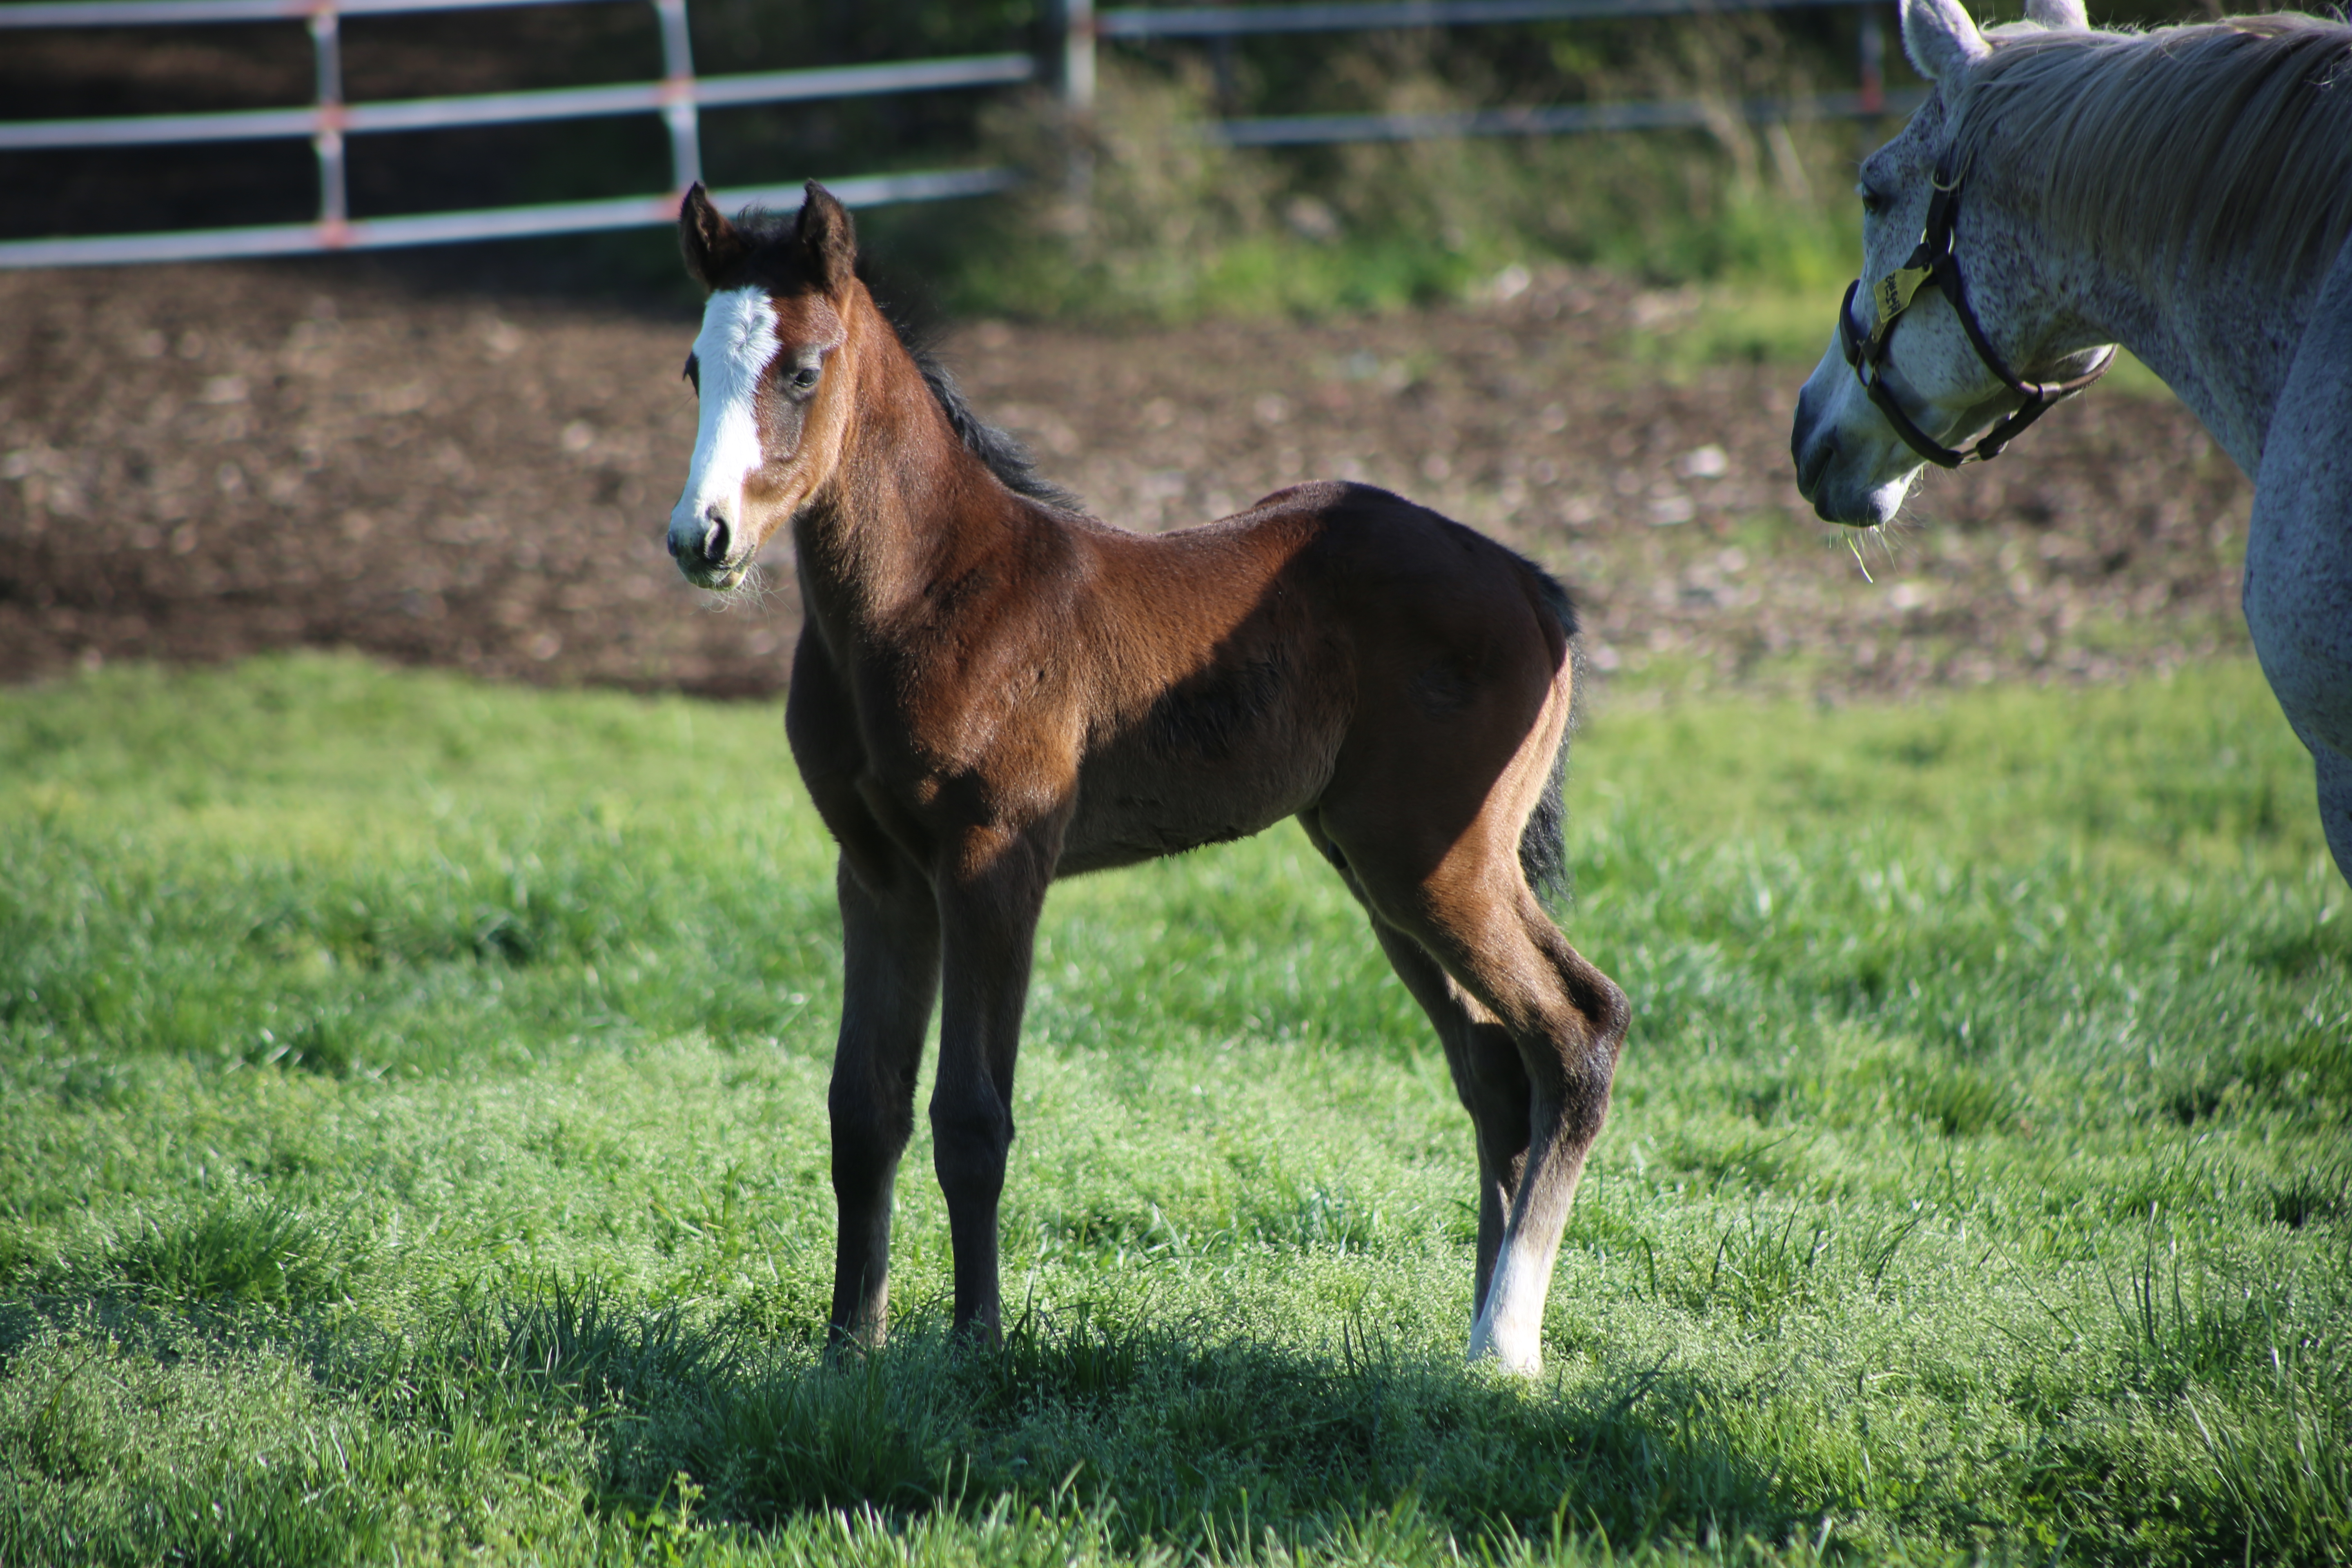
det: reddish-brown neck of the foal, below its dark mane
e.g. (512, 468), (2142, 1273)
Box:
(793, 296), (1030, 630)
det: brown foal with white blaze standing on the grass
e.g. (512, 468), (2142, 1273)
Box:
(668, 183), (1628, 1373)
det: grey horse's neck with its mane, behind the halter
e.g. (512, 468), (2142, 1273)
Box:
(1945, 16), (2352, 477)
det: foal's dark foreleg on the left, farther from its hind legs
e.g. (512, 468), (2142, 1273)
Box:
(826, 863), (938, 1345)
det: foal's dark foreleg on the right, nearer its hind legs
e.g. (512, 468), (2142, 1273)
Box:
(931, 839), (1051, 1345)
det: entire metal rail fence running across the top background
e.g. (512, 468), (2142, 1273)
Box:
(0, 0), (1917, 268)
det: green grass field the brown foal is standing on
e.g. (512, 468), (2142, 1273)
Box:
(0, 658), (2352, 1566)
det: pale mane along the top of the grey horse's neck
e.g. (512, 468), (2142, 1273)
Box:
(1947, 14), (2352, 285)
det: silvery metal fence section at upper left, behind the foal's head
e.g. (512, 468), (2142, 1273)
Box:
(0, 0), (1037, 268)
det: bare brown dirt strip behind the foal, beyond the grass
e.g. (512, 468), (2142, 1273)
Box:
(0, 258), (2251, 701)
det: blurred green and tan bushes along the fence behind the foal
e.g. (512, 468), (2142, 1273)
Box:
(931, 19), (1853, 320)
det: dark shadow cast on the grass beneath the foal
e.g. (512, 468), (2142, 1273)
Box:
(496, 1293), (1820, 1549)
